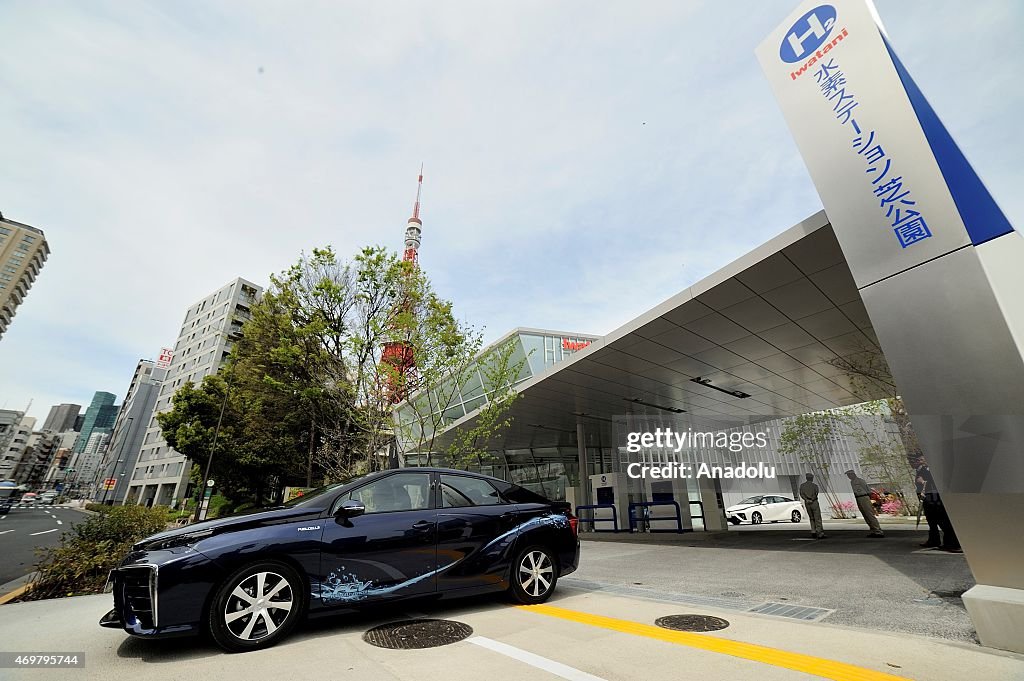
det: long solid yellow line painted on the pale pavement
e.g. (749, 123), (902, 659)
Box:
(518, 605), (906, 681)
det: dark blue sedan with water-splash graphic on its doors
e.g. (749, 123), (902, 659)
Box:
(99, 468), (580, 651)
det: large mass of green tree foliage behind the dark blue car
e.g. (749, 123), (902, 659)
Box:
(158, 242), (512, 501)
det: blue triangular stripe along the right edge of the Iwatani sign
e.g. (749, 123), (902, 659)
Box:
(882, 35), (1014, 246)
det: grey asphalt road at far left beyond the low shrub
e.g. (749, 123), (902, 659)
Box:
(0, 506), (86, 584)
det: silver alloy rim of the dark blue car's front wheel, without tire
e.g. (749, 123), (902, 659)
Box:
(224, 571), (295, 641)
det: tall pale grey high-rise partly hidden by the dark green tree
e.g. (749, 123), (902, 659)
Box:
(125, 278), (263, 506)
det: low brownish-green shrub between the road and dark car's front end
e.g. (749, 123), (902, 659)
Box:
(20, 506), (167, 600)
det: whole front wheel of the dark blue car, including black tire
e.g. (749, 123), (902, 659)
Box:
(209, 561), (305, 652)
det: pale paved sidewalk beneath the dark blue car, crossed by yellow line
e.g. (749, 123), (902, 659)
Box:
(0, 590), (1024, 681)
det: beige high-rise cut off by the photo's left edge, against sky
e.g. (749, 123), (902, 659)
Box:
(0, 213), (50, 338)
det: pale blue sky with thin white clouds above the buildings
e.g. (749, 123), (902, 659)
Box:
(0, 0), (1024, 419)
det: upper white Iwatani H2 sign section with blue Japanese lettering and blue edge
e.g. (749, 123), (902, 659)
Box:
(756, 0), (1012, 288)
